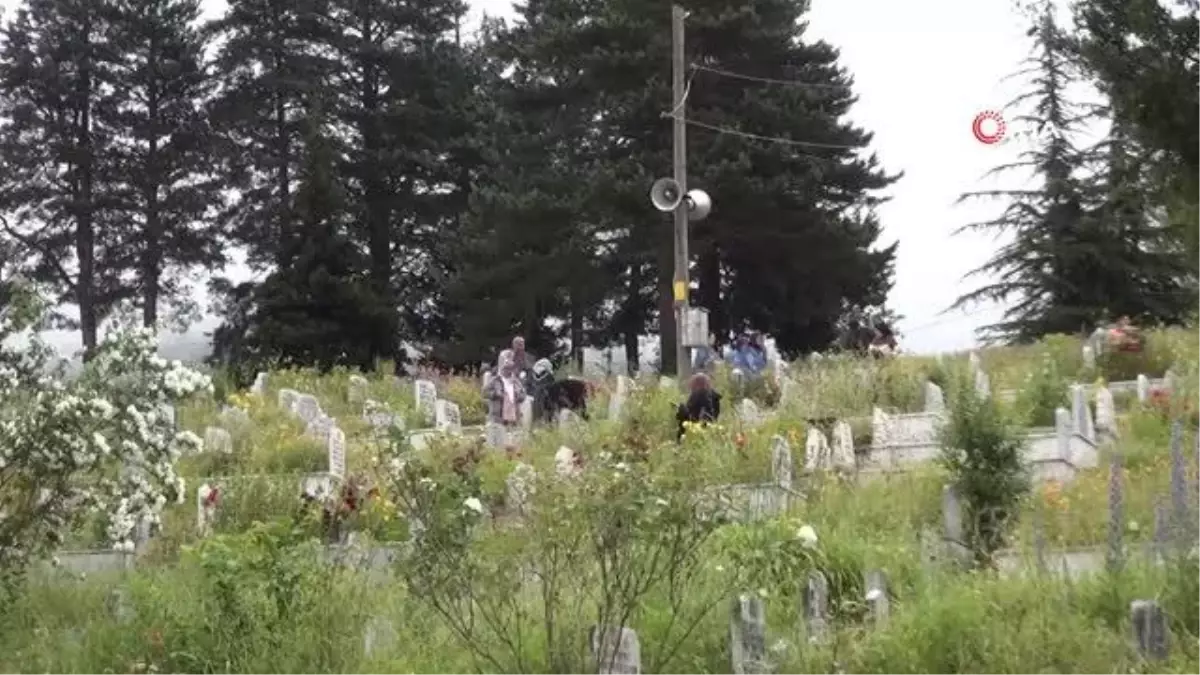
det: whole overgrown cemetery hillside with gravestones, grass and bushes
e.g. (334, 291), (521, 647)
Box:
(0, 317), (1200, 675)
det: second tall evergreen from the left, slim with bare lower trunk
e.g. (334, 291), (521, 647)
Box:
(105, 0), (226, 327)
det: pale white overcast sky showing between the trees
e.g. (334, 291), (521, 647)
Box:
(0, 0), (1070, 352)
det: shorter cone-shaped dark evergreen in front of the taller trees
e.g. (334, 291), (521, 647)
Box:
(207, 106), (396, 370)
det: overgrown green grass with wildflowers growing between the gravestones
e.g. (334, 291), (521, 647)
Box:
(0, 331), (1200, 675)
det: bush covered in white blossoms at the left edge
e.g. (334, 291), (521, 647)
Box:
(0, 299), (211, 580)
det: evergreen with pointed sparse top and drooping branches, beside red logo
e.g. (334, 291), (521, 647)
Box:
(956, 4), (1190, 341)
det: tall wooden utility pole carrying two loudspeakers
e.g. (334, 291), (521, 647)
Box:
(671, 5), (691, 384)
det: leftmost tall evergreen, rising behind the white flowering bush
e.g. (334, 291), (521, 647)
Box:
(0, 0), (133, 358)
